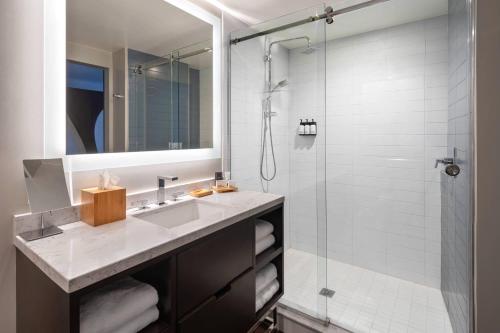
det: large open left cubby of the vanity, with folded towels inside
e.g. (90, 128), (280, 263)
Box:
(75, 257), (175, 333)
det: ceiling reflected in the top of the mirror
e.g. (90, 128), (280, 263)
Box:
(67, 0), (212, 56)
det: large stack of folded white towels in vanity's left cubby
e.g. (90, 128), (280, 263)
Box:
(80, 277), (158, 333)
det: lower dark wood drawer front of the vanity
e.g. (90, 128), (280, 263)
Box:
(178, 270), (255, 333)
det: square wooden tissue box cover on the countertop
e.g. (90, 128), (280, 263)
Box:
(80, 186), (126, 226)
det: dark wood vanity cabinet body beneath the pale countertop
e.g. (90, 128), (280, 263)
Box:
(17, 204), (283, 333)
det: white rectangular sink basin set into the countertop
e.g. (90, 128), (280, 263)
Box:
(135, 199), (227, 229)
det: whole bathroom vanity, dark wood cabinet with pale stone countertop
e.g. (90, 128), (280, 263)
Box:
(14, 192), (284, 333)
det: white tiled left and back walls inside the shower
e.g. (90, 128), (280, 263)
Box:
(231, 17), (448, 287)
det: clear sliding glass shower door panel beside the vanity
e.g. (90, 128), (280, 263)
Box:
(229, 6), (327, 320)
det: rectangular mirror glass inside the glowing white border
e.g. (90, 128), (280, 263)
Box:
(66, 0), (213, 155)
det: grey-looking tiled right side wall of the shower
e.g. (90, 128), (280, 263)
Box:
(441, 0), (474, 333)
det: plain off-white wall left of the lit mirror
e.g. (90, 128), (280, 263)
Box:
(0, 0), (43, 333)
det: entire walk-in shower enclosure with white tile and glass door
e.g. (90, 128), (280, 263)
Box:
(229, 0), (473, 333)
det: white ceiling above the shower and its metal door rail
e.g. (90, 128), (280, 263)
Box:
(222, 0), (448, 48)
